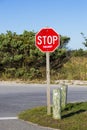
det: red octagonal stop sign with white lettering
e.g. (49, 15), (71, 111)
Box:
(35, 28), (60, 52)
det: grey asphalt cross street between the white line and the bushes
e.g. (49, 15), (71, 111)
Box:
(0, 84), (87, 117)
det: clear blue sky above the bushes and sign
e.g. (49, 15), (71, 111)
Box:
(0, 0), (87, 50)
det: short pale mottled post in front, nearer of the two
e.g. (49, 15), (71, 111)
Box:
(53, 88), (61, 119)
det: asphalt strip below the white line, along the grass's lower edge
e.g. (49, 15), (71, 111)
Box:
(0, 119), (58, 130)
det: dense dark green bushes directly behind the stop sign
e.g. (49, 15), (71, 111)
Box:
(0, 30), (70, 79)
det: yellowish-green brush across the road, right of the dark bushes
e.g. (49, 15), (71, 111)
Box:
(56, 56), (87, 80)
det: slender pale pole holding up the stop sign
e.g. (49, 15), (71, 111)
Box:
(46, 52), (51, 115)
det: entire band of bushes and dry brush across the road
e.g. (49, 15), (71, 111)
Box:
(0, 30), (87, 82)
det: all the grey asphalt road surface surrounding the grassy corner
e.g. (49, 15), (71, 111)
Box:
(0, 84), (87, 130)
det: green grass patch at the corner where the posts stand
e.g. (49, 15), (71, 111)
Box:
(19, 102), (87, 130)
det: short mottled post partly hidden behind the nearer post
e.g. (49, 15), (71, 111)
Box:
(61, 84), (68, 108)
